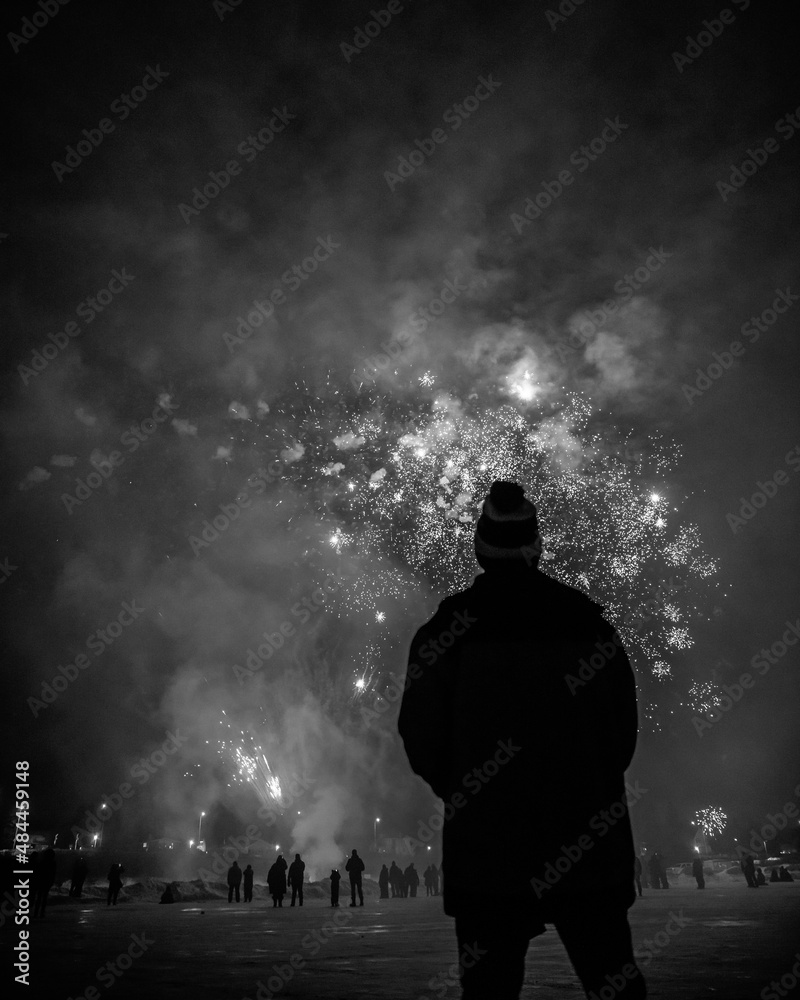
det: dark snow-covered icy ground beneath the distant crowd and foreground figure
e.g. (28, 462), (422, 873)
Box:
(10, 876), (800, 1000)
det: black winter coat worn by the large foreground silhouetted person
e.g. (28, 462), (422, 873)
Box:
(398, 569), (637, 915)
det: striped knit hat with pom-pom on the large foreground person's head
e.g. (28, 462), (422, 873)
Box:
(475, 479), (541, 563)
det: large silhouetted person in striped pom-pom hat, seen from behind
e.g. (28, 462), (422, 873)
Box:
(398, 481), (646, 1000)
